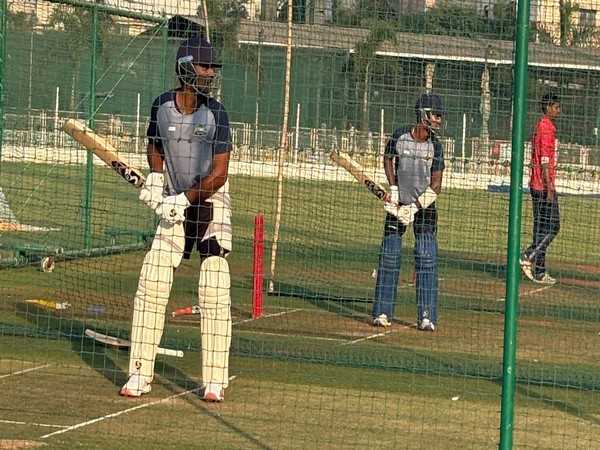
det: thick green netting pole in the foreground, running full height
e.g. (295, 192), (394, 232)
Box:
(499, 0), (530, 450)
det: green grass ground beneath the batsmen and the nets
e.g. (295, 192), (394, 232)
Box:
(0, 162), (600, 448)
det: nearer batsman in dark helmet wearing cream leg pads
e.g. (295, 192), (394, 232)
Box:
(120, 37), (231, 402)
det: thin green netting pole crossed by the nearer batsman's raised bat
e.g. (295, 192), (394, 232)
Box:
(83, 6), (98, 248)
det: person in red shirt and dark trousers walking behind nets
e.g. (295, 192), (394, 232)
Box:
(520, 94), (560, 285)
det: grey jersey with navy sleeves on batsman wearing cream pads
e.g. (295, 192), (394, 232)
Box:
(147, 91), (231, 195)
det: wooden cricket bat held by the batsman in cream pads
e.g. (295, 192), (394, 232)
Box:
(63, 119), (146, 188)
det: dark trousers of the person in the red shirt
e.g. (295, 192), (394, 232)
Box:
(525, 190), (560, 277)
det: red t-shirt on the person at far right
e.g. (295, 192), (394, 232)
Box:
(529, 116), (558, 191)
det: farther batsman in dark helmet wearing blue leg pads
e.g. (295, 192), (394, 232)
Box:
(372, 94), (445, 331)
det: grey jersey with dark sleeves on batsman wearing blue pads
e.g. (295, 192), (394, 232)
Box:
(385, 128), (444, 204)
